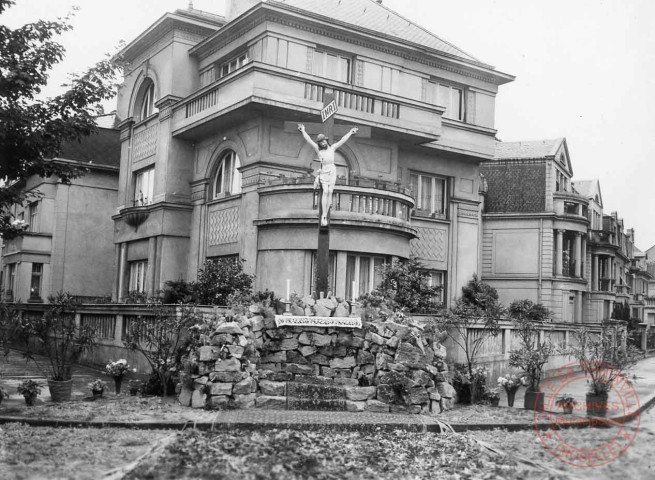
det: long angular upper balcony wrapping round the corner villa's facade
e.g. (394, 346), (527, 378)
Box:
(172, 61), (443, 142)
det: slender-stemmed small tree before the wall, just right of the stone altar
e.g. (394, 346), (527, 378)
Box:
(438, 275), (504, 403)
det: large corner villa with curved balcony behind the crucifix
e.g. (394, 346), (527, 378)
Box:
(113, 0), (513, 299)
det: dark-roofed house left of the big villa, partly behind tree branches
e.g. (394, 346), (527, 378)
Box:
(2, 119), (120, 302)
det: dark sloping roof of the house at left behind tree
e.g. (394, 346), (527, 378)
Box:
(57, 128), (121, 167)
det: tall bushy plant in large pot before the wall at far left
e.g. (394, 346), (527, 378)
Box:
(18, 292), (95, 402)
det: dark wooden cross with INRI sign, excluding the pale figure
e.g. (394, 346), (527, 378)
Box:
(285, 93), (371, 298)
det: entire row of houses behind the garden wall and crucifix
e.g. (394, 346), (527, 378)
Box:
(2, 0), (655, 332)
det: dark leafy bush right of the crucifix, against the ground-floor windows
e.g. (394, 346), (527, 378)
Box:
(366, 258), (441, 313)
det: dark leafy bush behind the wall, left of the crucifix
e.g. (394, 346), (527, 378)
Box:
(193, 258), (255, 305)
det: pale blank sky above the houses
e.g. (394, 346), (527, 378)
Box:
(5, 0), (655, 250)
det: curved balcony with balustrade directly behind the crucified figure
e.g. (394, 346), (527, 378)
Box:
(255, 176), (416, 238)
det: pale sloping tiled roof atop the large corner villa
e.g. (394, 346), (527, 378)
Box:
(267, 0), (488, 66)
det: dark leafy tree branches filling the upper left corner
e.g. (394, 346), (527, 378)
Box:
(0, 0), (120, 238)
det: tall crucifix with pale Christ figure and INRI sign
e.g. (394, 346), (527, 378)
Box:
(288, 93), (370, 298)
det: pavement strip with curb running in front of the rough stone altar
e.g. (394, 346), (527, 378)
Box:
(0, 351), (655, 432)
